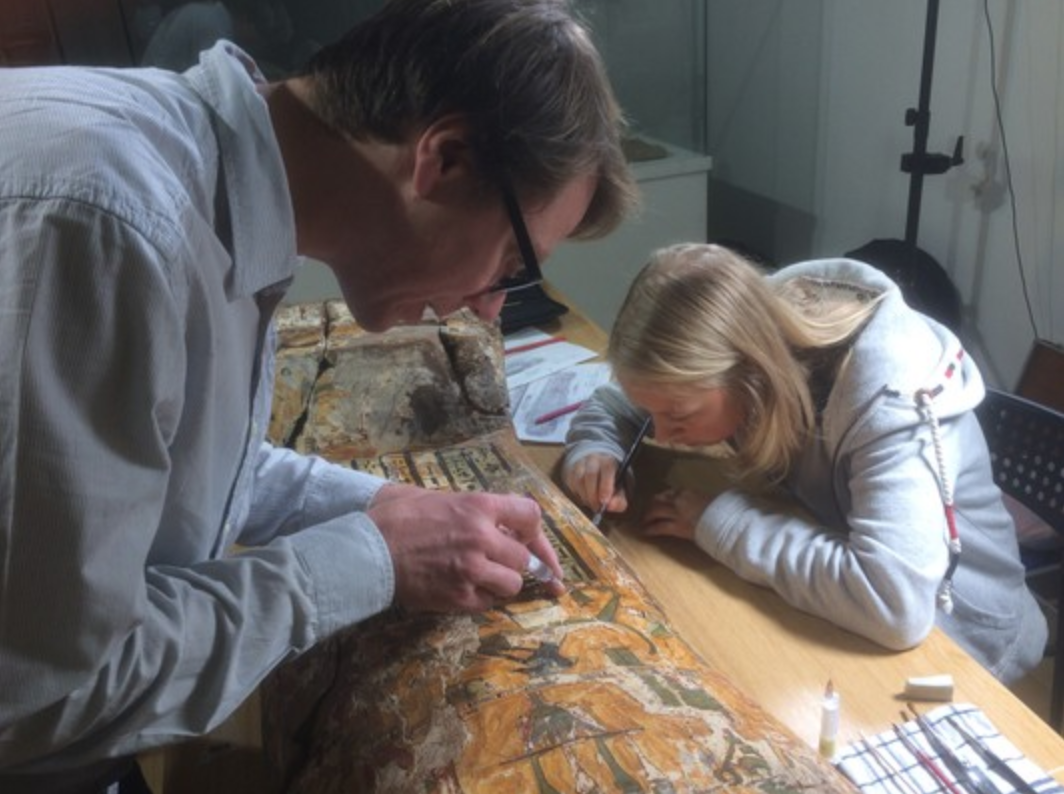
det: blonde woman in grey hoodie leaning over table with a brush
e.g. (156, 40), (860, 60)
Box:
(563, 245), (1047, 681)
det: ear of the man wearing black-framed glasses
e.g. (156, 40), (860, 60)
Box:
(413, 114), (476, 200)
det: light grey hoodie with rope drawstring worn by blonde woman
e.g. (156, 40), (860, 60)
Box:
(565, 259), (1047, 682)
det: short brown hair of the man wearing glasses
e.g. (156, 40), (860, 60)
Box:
(305, 0), (636, 238)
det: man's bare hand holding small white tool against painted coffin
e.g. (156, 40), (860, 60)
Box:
(368, 485), (565, 612)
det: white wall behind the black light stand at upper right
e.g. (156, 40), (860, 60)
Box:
(816, 0), (1064, 386)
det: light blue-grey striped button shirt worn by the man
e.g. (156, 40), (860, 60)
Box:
(0, 43), (394, 790)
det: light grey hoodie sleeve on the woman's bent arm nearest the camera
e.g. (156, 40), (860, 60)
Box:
(695, 415), (948, 650)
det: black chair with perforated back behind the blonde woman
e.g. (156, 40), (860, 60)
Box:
(976, 388), (1064, 731)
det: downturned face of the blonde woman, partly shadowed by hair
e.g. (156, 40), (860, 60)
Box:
(618, 378), (746, 447)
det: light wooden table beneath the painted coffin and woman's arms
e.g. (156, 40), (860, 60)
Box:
(525, 285), (1064, 783)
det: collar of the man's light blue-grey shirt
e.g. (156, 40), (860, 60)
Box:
(185, 40), (298, 295)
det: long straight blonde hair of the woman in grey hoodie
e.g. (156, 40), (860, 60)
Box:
(608, 244), (878, 479)
